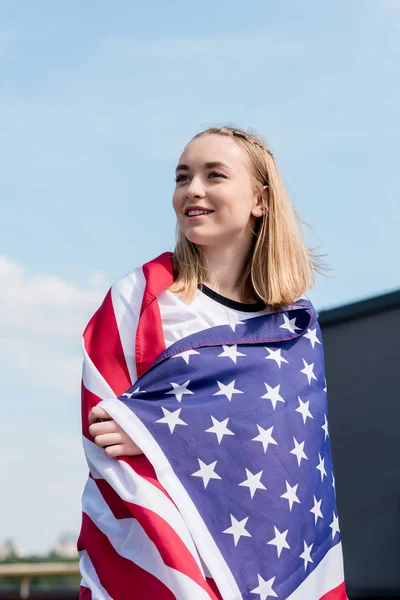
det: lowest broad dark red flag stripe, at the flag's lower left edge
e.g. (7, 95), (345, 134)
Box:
(80, 513), (175, 600)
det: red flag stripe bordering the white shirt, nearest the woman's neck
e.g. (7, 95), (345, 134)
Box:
(136, 252), (174, 378)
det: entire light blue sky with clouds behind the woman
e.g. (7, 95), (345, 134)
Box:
(0, 0), (400, 551)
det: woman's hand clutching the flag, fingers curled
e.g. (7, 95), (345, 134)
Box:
(89, 406), (143, 457)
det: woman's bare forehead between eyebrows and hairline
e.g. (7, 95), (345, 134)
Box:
(179, 134), (248, 168)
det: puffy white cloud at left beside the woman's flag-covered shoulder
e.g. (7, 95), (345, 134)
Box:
(0, 256), (106, 394)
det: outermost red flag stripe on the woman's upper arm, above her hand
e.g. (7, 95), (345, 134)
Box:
(83, 290), (132, 396)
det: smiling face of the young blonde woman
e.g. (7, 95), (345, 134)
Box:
(172, 134), (263, 246)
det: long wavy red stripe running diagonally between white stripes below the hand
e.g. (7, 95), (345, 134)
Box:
(95, 479), (217, 600)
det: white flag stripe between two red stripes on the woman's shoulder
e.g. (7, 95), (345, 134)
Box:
(111, 267), (146, 384)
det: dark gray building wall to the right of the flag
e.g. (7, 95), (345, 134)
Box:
(320, 291), (400, 599)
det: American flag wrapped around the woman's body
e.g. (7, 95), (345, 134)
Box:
(78, 255), (347, 600)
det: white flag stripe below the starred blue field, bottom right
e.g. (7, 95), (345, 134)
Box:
(287, 542), (344, 600)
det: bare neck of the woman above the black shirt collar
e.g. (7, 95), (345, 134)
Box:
(202, 236), (250, 302)
